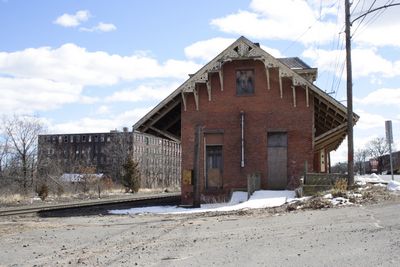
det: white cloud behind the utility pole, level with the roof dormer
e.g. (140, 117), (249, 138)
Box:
(302, 48), (400, 78)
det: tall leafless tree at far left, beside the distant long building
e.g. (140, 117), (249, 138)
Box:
(2, 115), (44, 193)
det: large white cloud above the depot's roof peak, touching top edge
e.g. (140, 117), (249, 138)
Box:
(211, 0), (341, 44)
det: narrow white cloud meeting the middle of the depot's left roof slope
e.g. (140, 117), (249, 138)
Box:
(105, 82), (180, 102)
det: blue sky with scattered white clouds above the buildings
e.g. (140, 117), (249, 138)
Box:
(0, 0), (400, 163)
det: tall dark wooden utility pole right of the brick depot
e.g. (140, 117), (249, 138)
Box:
(345, 0), (354, 186)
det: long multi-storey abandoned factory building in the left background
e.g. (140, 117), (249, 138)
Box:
(38, 128), (181, 187)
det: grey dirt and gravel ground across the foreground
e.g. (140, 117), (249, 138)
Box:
(0, 189), (400, 266)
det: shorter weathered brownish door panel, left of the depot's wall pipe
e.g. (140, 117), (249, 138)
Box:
(206, 145), (223, 189)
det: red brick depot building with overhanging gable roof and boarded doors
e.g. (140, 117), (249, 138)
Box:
(133, 37), (358, 205)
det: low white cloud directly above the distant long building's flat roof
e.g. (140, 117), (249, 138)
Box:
(48, 108), (151, 133)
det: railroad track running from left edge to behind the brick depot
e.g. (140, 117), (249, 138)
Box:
(0, 193), (181, 216)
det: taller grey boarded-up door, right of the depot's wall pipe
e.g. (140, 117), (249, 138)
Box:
(267, 132), (287, 189)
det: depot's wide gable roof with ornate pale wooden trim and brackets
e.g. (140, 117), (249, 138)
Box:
(133, 36), (359, 151)
